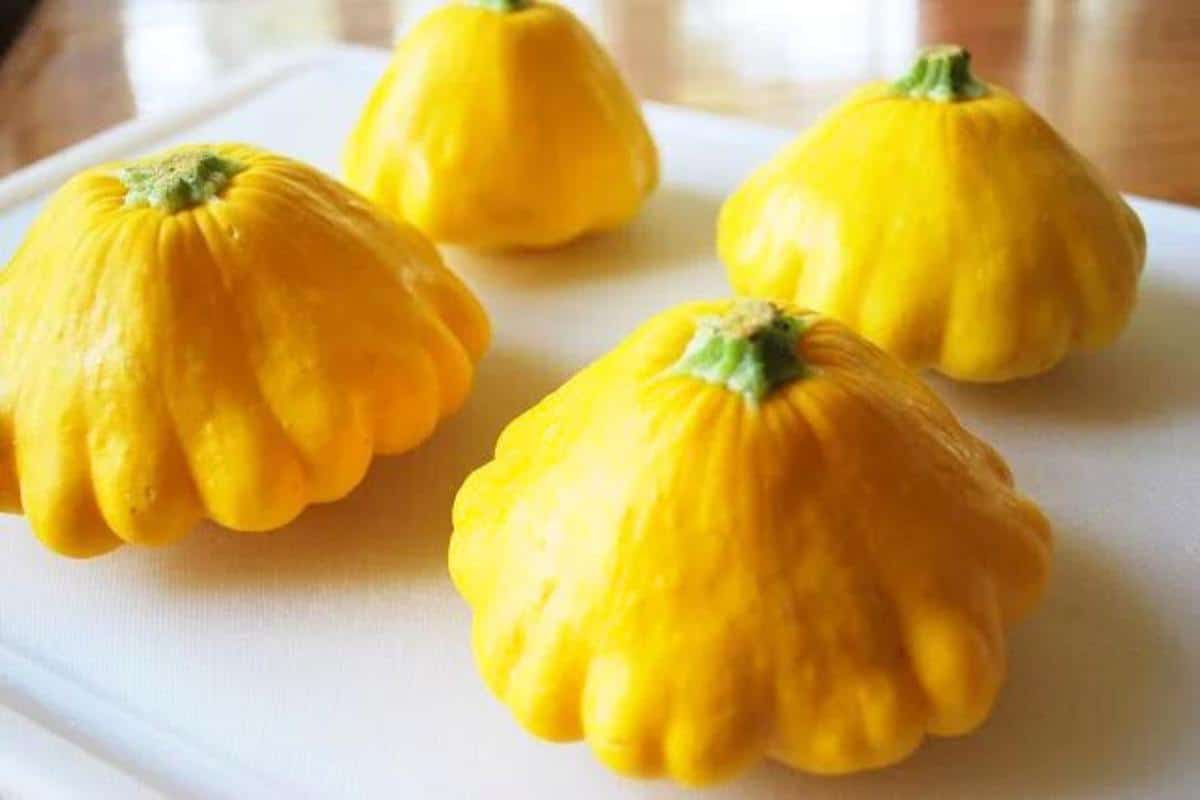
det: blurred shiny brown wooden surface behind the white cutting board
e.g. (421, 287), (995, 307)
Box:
(0, 0), (1200, 205)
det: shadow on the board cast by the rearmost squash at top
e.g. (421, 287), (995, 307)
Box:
(446, 186), (721, 291)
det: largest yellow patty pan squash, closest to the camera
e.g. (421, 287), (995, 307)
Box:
(450, 300), (1050, 784)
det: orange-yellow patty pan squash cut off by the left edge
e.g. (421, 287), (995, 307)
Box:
(0, 144), (488, 557)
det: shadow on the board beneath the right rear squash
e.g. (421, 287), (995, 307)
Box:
(936, 281), (1200, 426)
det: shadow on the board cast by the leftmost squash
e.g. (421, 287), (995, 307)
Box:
(156, 350), (569, 593)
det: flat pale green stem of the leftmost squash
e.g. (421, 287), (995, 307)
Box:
(116, 148), (245, 213)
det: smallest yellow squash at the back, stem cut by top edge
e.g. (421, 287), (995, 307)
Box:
(343, 0), (659, 249)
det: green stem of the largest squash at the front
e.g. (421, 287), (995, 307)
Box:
(671, 300), (808, 404)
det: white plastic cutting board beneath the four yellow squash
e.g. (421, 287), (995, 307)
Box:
(0, 48), (1200, 800)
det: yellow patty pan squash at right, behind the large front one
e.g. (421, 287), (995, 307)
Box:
(718, 46), (1146, 381)
